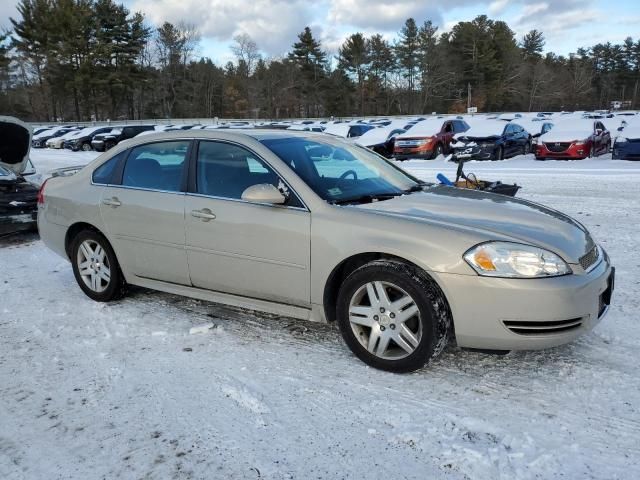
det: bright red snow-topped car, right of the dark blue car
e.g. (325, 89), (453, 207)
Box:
(536, 118), (611, 160)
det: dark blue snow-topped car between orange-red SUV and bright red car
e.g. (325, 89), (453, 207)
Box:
(451, 120), (531, 161)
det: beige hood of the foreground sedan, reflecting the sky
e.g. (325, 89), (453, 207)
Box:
(356, 186), (594, 263)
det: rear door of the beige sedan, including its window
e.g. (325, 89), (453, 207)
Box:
(100, 140), (192, 285)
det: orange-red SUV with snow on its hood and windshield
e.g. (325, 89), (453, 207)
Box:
(393, 118), (469, 160)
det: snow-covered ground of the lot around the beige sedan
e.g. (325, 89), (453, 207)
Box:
(0, 151), (640, 480)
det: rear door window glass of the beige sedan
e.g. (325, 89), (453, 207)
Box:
(122, 140), (189, 192)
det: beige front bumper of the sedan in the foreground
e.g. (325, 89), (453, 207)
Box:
(437, 254), (615, 350)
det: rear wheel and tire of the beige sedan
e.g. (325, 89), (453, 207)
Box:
(71, 230), (126, 302)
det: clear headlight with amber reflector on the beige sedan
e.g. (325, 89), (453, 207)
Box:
(464, 242), (572, 278)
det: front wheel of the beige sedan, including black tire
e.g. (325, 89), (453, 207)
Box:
(337, 260), (451, 373)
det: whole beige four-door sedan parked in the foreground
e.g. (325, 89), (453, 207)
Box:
(38, 130), (614, 372)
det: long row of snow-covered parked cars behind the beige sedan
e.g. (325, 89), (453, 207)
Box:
(26, 110), (638, 161)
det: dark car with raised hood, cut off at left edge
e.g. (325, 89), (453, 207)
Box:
(0, 117), (39, 236)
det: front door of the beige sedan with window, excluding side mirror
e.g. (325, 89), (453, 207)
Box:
(185, 141), (311, 306)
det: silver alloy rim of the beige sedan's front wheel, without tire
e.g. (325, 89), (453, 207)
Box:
(349, 281), (422, 360)
